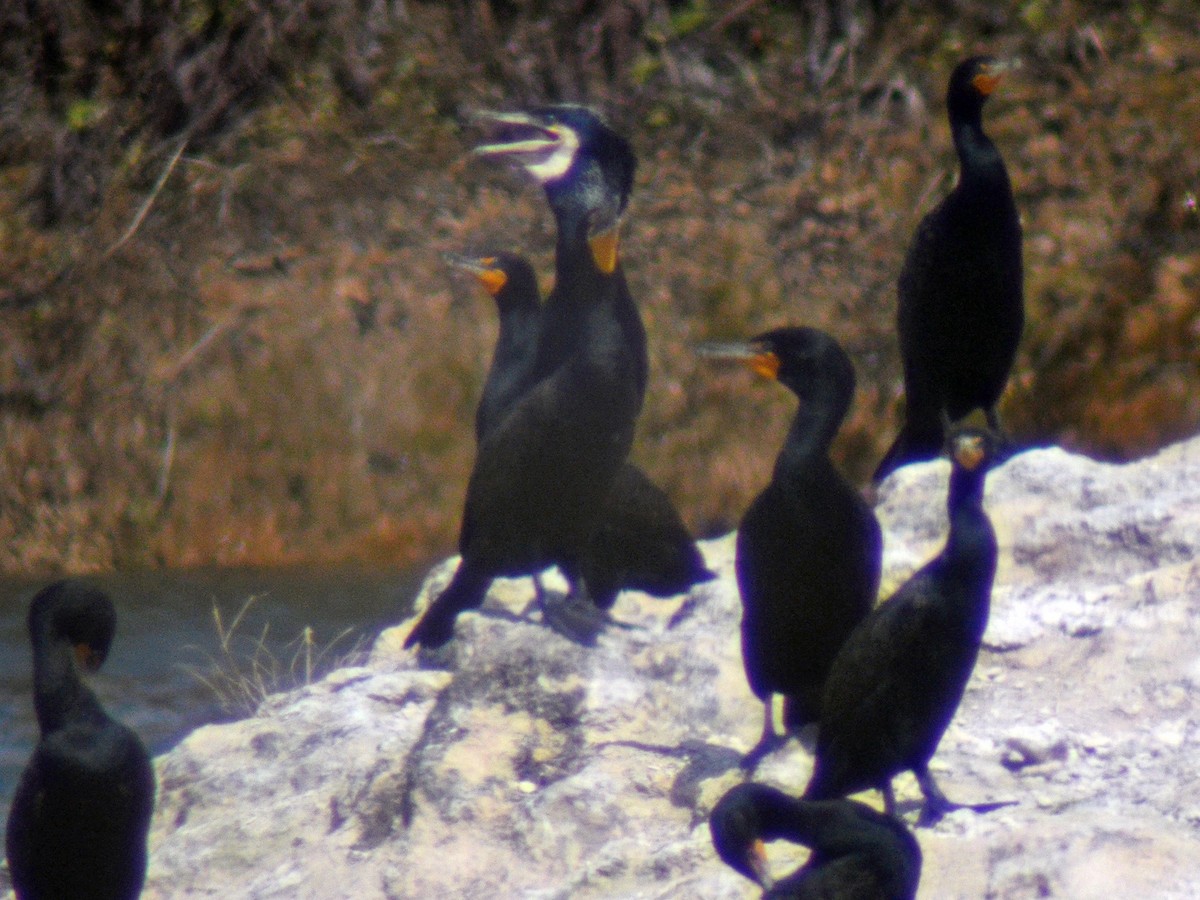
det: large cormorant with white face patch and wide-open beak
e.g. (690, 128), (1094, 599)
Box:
(404, 106), (648, 647)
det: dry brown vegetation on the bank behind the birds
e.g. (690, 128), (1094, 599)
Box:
(0, 0), (1200, 571)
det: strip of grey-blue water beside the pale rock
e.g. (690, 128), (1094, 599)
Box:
(0, 569), (424, 849)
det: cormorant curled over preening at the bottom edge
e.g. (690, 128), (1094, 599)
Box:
(708, 782), (922, 900)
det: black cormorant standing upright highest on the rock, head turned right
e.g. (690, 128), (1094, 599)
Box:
(874, 56), (1025, 482)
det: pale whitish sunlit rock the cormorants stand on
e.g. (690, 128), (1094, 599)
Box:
(98, 440), (1200, 900)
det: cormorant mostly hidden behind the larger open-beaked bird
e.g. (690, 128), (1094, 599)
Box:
(448, 253), (715, 610)
